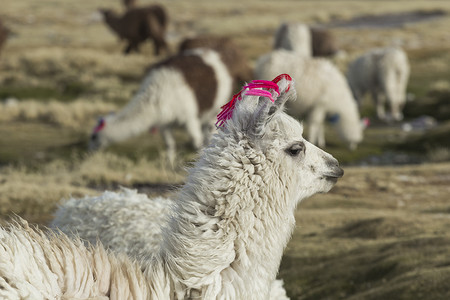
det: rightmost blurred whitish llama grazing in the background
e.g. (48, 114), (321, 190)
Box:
(347, 48), (410, 121)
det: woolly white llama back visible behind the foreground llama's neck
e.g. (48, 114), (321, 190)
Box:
(51, 188), (172, 257)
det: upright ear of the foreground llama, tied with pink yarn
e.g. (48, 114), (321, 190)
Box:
(247, 78), (296, 137)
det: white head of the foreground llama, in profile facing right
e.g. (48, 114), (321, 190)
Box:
(219, 75), (343, 206)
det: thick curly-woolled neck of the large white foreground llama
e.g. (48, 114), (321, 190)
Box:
(151, 135), (295, 299)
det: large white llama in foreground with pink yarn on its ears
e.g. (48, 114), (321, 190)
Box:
(0, 77), (343, 299)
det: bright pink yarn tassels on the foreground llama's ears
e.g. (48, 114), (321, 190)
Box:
(216, 74), (292, 127)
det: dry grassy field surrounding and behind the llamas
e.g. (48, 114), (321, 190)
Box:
(0, 0), (450, 299)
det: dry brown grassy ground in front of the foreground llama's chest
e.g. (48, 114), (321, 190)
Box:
(280, 163), (450, 299)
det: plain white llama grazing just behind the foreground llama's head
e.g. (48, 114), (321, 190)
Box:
(255, 50), (364, 149)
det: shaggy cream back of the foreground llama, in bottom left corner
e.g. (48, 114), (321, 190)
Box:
(0, 220), (149, 299)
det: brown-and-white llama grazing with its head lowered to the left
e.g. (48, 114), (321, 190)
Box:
(89, 49), (233, 163)
